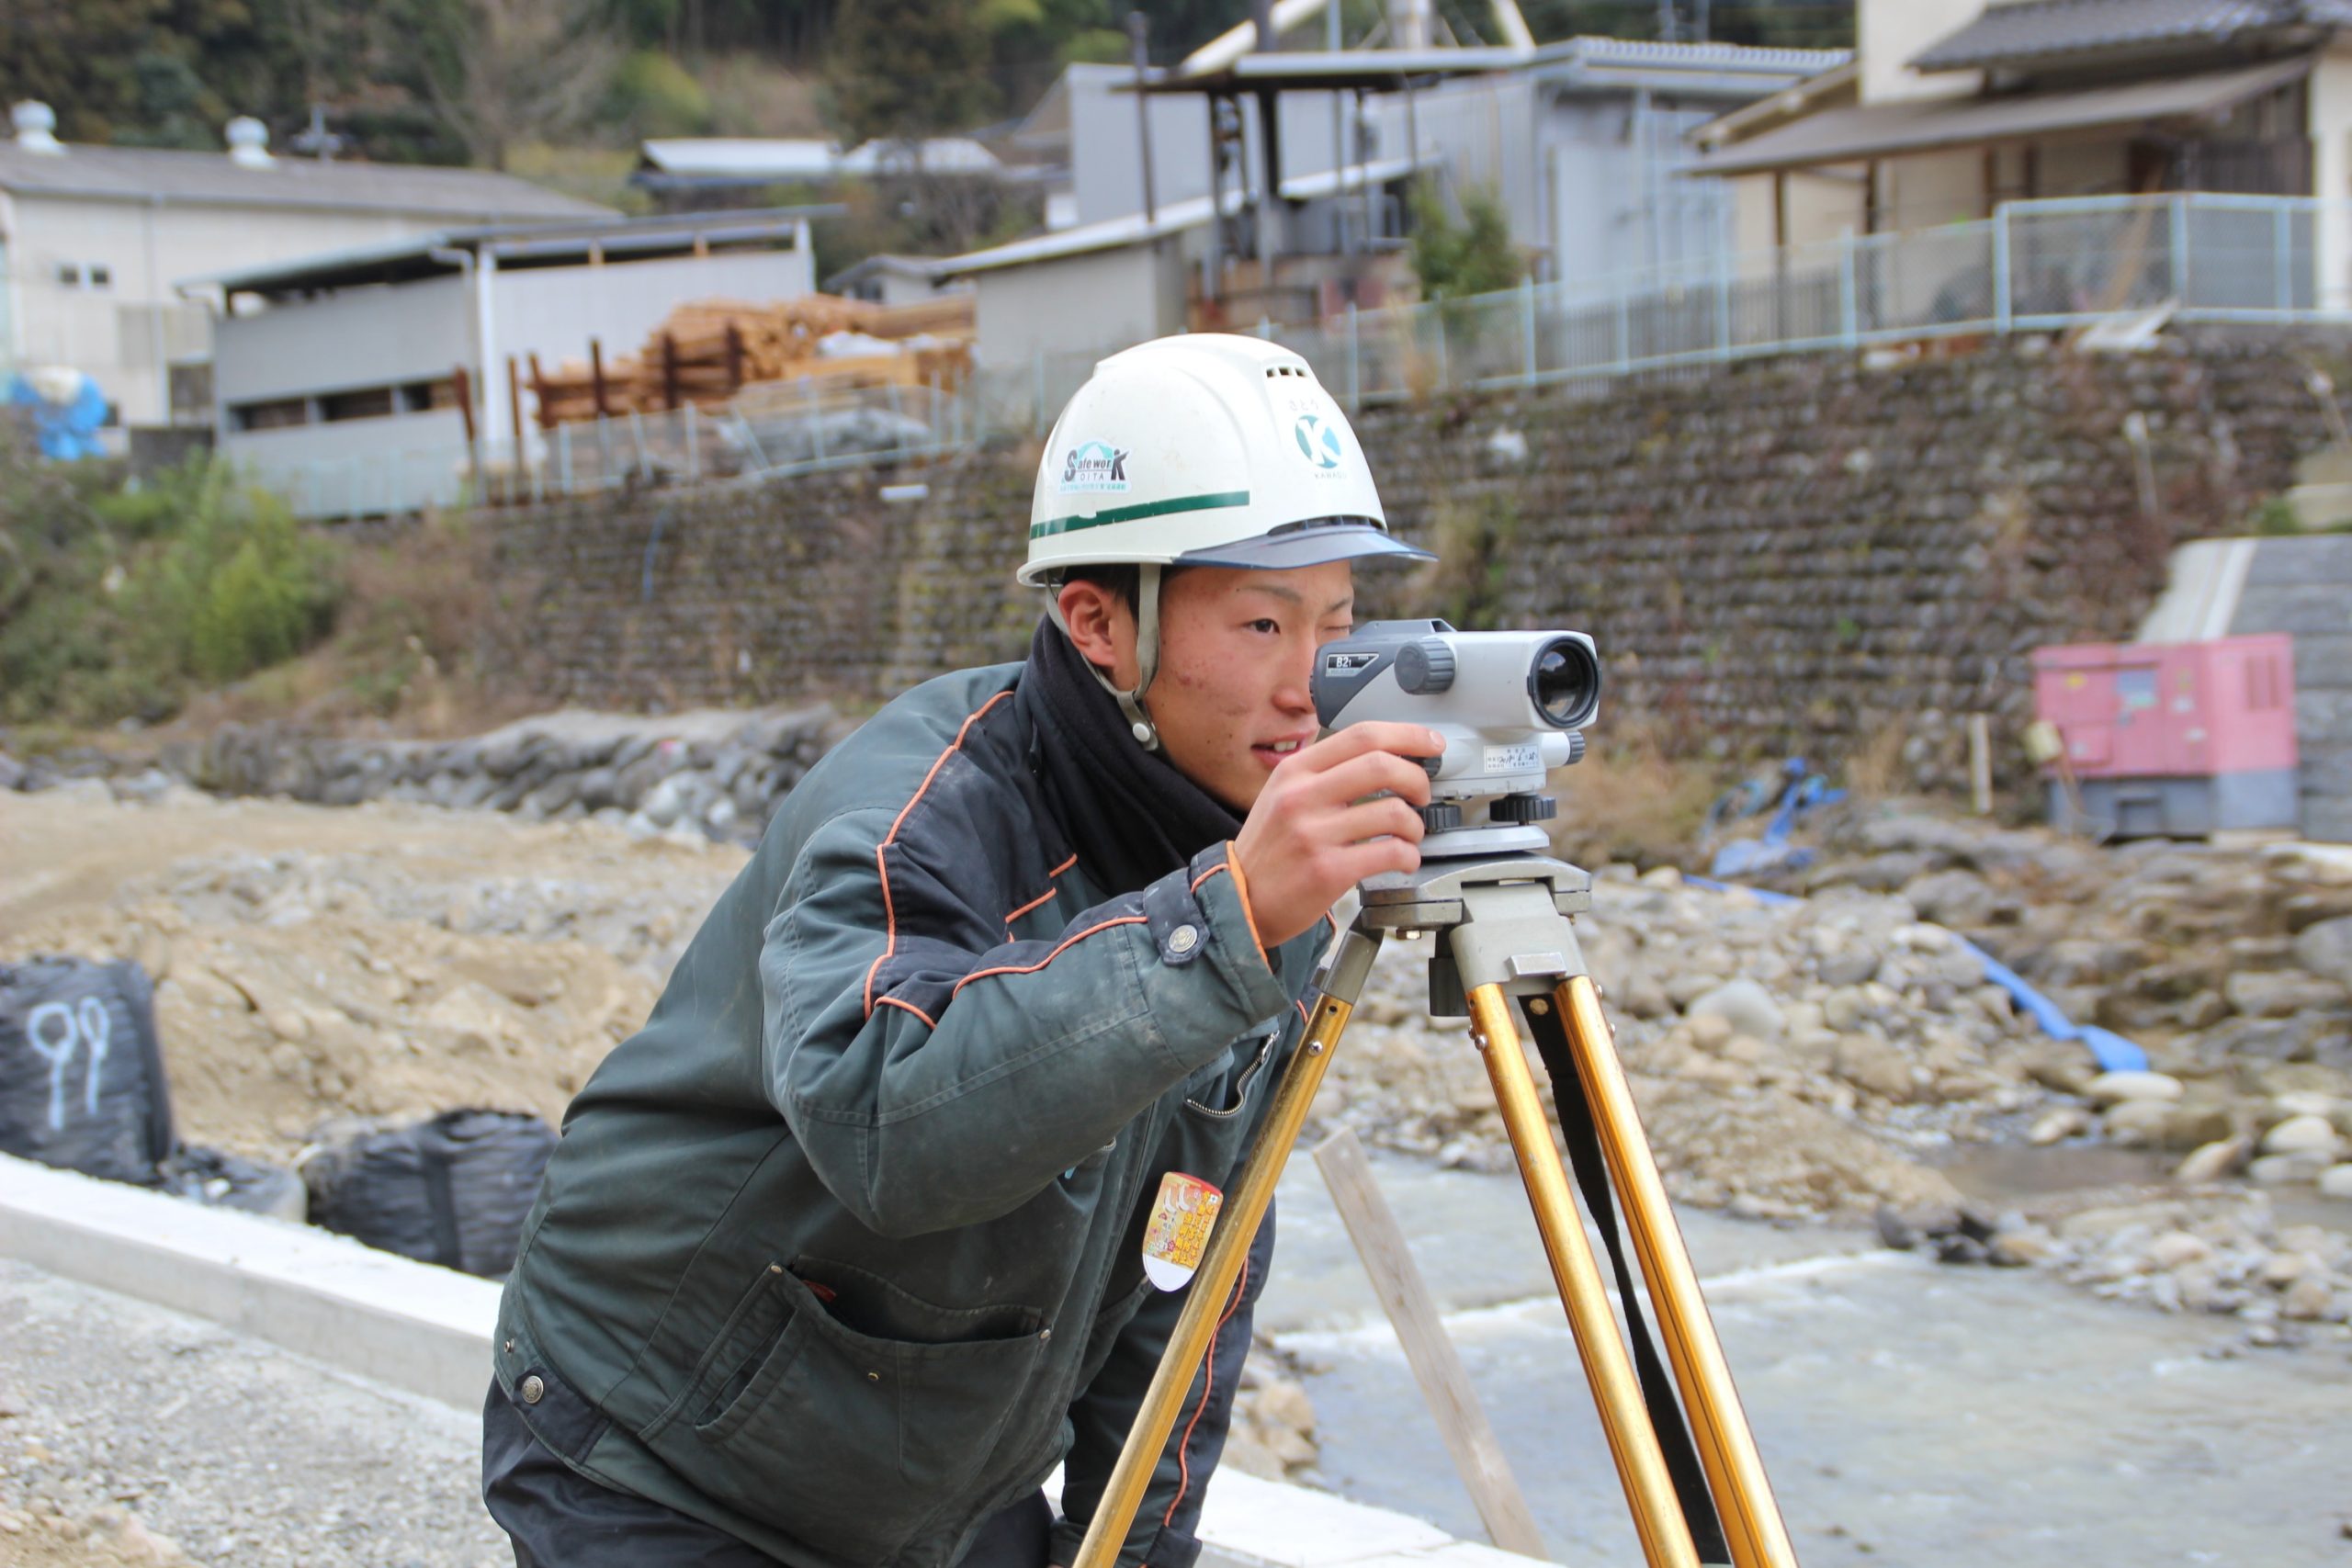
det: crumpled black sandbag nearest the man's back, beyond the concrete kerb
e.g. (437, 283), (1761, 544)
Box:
(301, 1110), (555, 1277)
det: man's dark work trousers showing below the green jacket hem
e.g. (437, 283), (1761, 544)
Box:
(482, 1378), (1054, 1568)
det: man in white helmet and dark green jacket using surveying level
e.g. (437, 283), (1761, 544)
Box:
(484, 333), (1440, 1568)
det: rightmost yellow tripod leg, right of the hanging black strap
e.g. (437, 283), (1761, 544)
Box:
(1543, 976), (1797, 1568)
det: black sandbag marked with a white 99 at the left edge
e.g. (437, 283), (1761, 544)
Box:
(0, 957), (172, 1187)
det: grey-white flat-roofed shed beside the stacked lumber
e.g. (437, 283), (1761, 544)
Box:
(204, 211), (814, 514)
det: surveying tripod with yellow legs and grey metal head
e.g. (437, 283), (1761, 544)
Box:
(1072, 853), (1797, 1568)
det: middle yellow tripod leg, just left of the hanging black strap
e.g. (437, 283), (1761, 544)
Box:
(1470, 985), (1698, 1568)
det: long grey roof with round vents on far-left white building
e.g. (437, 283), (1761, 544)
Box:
(0, 141), (612, 221)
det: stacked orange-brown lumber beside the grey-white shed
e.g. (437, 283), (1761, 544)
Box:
(532, 294), (971, 425)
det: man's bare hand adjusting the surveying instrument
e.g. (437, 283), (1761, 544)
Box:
(1232, 724), (1444, 952)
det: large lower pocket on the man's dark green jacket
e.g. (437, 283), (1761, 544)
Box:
(677, 1258), (1045, 1563)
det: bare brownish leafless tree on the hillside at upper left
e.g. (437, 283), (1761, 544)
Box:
(419, 0), (621, 169)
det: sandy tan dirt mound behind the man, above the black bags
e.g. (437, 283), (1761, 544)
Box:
(0, 795), (743, 1164)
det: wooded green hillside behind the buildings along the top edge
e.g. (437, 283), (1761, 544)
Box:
(0, 0), (1853, 172)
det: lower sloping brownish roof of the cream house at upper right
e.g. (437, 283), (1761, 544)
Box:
(1681, 56), (2312, 174)
